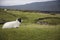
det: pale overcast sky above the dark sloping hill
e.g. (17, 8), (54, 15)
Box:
(0, 0), (55, 6)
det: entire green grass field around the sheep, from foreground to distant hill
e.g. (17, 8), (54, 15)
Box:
(0, 10), (60, 40)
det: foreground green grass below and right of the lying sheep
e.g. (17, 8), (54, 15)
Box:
(0, 24), (60, 40)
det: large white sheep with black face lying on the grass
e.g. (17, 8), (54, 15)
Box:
(2, 18), (21, 29)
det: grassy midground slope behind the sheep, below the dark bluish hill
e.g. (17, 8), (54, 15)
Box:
(0, 10), (60, 24)
